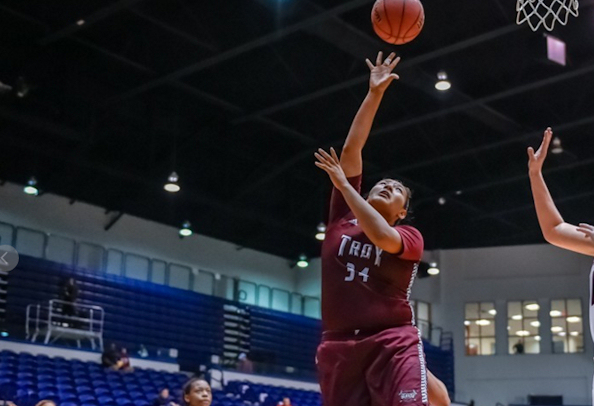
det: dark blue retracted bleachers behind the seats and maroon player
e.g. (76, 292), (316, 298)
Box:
(7, 256), (454, 394)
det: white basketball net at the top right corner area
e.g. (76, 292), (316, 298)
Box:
(516, 0), (579, 31)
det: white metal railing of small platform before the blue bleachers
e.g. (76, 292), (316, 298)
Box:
(25, 299), (105, 350)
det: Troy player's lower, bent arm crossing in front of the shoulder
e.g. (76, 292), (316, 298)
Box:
(315, 148), (402, 254)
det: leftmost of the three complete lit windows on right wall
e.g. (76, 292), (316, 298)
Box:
(464, 302), (497, 355)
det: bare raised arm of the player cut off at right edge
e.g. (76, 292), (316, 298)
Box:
(528, 127), (594, 255)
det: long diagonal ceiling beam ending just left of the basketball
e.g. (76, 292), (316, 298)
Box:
(107, 0), (369, 103)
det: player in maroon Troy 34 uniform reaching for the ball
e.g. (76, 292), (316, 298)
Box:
(315, 52), (449, 406)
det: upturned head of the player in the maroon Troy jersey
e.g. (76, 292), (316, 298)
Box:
(367, 179), (409, 221)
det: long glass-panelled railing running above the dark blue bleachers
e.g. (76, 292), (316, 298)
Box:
(0, 222), (320, 318)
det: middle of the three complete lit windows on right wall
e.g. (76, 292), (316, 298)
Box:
(507, 300), (540, 354)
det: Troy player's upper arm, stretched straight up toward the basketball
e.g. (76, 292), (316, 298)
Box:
(340, 51), (400, 177)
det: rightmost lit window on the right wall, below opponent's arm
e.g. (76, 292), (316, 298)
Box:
(550, 299), (584, 353)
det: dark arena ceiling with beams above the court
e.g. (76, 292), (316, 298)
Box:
(0, 0), (594, 259)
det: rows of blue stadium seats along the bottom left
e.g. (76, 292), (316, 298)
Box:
(0, 350), (321, 406)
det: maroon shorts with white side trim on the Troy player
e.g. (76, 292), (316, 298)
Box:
(316, 326), (428, 406)
